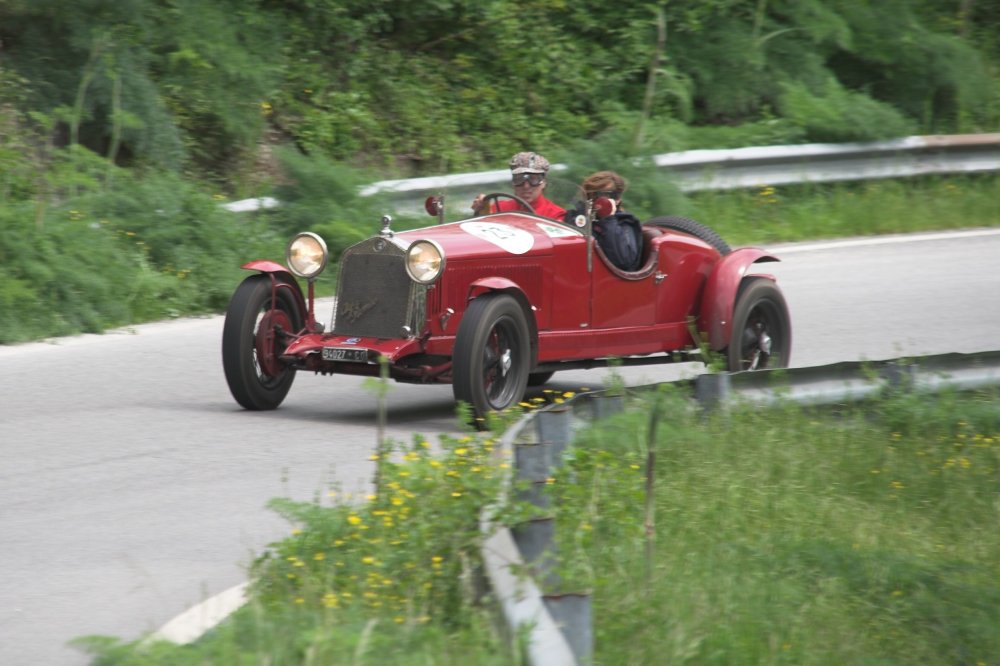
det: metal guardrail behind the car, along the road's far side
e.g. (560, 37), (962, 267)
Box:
(225, 133), (1000, 217)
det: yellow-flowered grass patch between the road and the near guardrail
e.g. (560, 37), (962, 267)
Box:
(77, 426), (521, 666)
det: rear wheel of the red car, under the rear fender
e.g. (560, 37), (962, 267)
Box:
(726, 278), (792, 372)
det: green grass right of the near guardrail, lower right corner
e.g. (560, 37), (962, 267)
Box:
(553, 386), (1000, 665)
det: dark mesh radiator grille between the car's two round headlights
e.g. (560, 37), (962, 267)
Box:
(333, 238), (426, 338)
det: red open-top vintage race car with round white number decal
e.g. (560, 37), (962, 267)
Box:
(222, 185), (791, 417)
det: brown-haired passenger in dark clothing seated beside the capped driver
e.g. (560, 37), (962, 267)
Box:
(583, 171), (642, 272)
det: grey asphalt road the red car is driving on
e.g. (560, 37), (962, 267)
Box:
(0, 229), (1000, 666)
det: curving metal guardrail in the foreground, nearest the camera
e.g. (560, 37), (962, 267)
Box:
(482, 351), (1000, 666)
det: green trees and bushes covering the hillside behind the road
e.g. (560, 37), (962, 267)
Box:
(0, 0), (1000, 343)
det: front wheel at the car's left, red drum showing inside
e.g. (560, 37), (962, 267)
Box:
(222, 275), (303, 410)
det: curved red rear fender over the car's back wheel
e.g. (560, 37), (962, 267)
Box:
(698, 247), (780, 351)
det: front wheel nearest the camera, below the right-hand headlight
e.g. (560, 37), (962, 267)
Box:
(452, 294), (531, 417)
